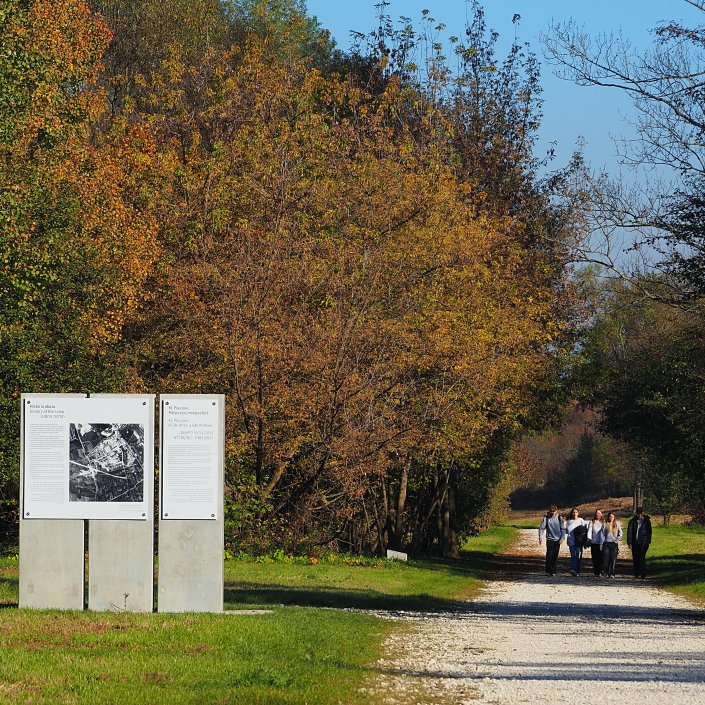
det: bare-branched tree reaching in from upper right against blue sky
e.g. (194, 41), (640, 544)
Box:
(545, 0), (705, 306)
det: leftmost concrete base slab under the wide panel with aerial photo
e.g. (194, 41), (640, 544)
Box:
(19, 519), (85, 610)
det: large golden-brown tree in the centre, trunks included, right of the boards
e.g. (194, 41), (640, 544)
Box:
(107, 2), (580, 554)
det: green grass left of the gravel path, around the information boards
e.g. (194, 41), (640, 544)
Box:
(0, 527), (515, 705)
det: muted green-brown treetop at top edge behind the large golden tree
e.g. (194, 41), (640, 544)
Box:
(90, 0), (342, 113)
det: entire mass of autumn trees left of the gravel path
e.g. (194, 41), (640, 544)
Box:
(0, 0), (581, 556)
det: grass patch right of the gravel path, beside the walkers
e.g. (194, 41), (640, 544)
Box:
(646, 524), (705, 602)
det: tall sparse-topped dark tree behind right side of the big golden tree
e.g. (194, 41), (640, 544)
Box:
(338, 3), (575, 553)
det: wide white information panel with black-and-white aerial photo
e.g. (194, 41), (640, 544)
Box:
(22, 394), (154, 520)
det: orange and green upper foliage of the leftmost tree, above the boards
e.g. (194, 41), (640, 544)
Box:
(0, 0), (158, 358)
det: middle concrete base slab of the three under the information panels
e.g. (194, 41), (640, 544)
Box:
(88, 519), (154, 612)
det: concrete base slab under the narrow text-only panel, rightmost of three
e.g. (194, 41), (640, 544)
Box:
(157, 519), (223, 612)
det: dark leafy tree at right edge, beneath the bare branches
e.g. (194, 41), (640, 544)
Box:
(584, 280), (705, 516)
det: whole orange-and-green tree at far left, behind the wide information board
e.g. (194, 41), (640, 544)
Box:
(0, 0), (156, 520)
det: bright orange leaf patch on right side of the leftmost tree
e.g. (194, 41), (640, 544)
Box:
(30, 121), (159, 352)
